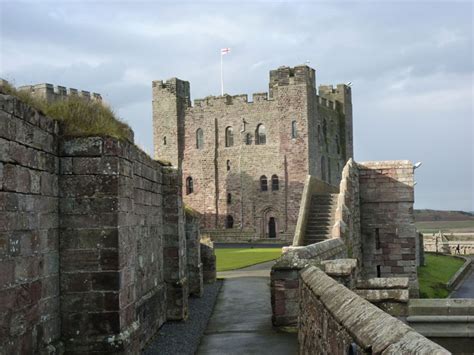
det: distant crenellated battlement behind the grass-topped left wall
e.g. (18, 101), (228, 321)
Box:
(18, 83), (102, 102)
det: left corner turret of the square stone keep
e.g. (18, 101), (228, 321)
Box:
(153, 78), (191, 170)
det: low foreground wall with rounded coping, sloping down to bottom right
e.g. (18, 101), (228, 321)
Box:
(298, 266), (450, 354)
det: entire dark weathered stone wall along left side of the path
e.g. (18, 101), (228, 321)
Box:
(0, 95), (212, 353)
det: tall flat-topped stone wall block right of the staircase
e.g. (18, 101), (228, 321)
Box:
(357, 161), (418, 296)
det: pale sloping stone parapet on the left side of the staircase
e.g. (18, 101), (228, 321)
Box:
(293, 175), (338, 246)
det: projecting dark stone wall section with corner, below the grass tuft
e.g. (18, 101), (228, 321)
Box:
(59, 137), (177, 352)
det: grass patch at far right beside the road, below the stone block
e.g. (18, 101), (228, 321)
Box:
(418, 254), (464, 298)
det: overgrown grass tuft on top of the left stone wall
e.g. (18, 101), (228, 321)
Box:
(1, 84), (131, 140)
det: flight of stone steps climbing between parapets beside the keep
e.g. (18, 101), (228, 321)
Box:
(304, 194), (337, 245)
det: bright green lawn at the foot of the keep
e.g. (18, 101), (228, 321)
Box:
(216, 248), (281, 271)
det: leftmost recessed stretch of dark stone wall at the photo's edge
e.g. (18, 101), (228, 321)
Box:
(0, 95), (60, 354)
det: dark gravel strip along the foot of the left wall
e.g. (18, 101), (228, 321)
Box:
(143, 280), (222, 355)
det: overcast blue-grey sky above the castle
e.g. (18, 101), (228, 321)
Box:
(0, 0), (474, 211)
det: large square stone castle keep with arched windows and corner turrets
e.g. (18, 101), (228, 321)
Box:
(153, 65), (353, 241)
